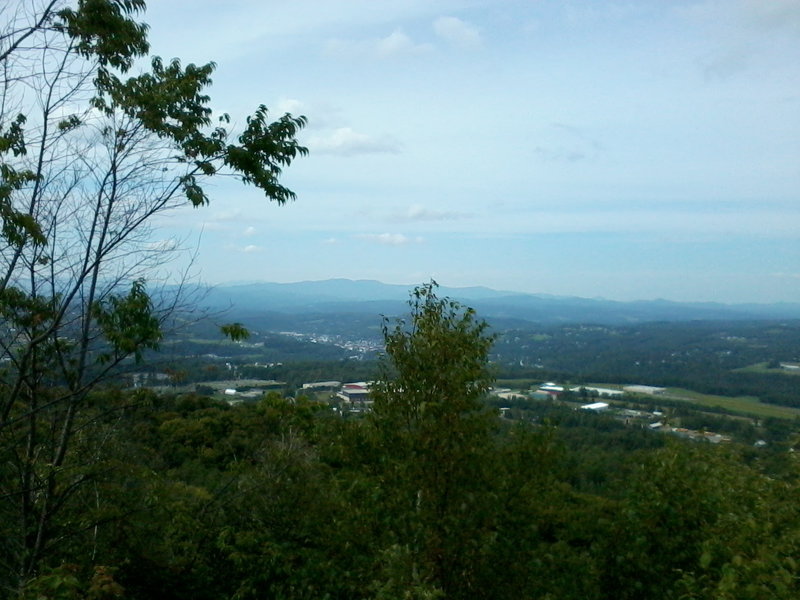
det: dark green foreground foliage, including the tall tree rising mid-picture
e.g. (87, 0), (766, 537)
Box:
(0, 286), (800, 600)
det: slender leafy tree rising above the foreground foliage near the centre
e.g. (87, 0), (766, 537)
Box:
(371, 282), (496, 598)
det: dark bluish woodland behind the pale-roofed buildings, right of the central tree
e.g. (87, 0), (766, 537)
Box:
(495, 321), (800, 406)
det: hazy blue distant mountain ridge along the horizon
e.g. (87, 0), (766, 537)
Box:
(197, 279), (800, 325)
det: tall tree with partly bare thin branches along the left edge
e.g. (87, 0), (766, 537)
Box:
(0, 0), (306, 588)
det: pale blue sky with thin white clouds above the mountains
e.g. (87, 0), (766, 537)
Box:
(142, 0), (800, 303)
